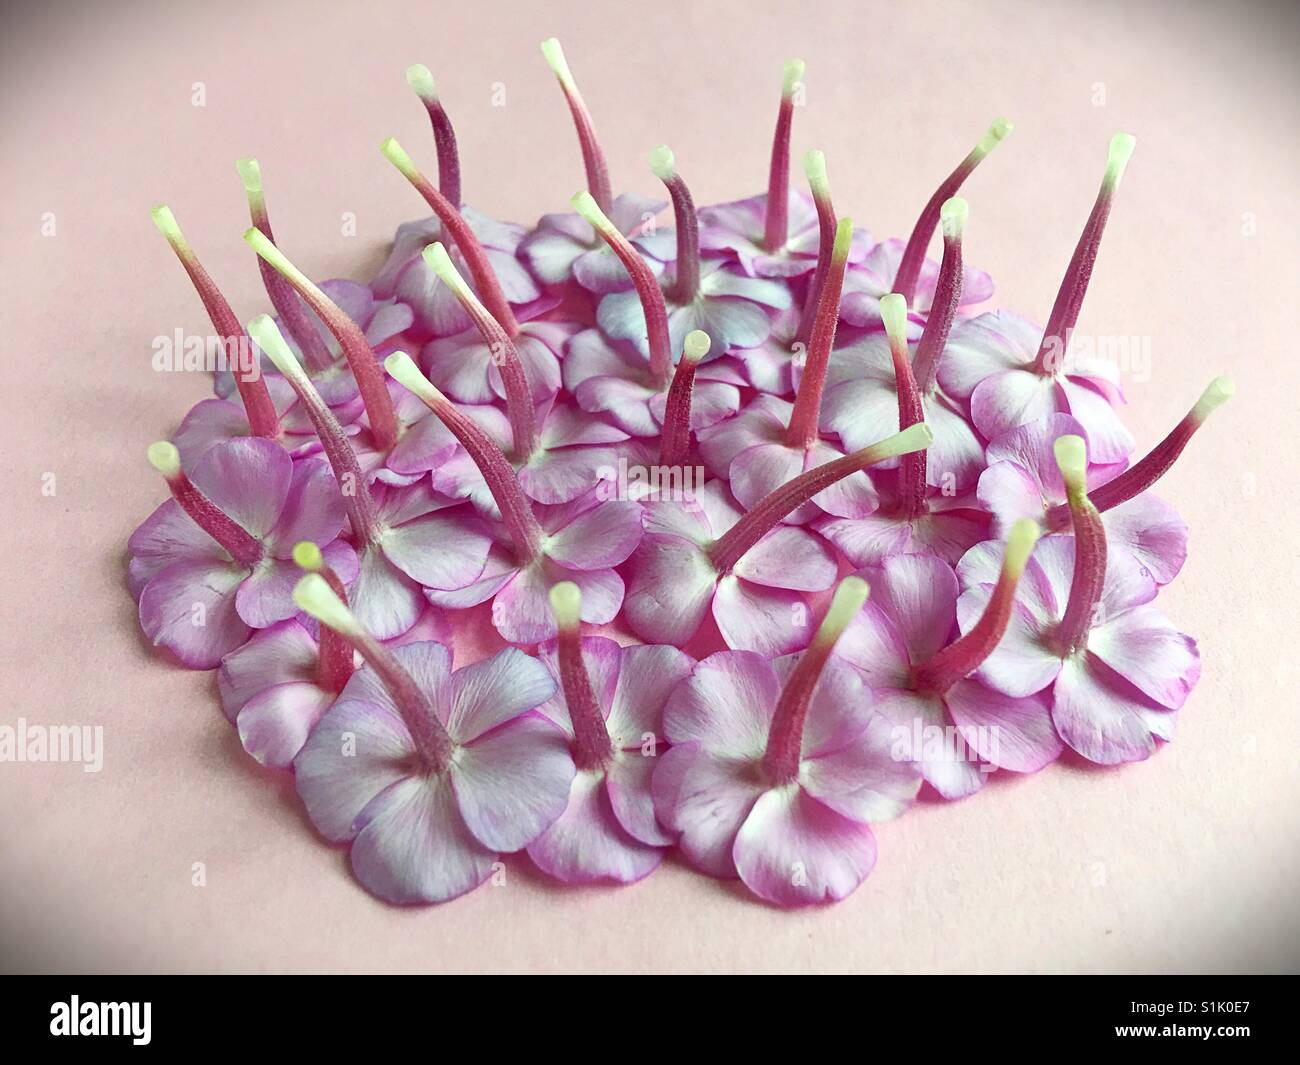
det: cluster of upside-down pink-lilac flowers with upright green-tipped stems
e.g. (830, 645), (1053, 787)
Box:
(129, 40), (1232, 905)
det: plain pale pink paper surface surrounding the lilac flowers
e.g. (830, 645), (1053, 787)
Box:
(0, 0), (1300, 973)
